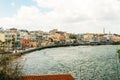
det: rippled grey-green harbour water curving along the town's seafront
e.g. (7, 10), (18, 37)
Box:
(18, 45), (120, 80)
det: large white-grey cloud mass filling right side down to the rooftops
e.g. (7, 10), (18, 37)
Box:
(33, 0), (120, 33)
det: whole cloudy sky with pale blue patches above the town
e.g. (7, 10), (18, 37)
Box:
(0, 0), (120, 34)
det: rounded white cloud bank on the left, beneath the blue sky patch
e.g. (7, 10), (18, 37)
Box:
(0, 6), (60, 30)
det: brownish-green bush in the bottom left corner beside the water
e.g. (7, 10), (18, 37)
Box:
(0, 54), (22, 80)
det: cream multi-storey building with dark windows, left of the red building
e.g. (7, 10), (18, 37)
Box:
(4, 28), (20, 50)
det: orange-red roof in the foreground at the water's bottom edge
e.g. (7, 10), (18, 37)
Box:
(22, 74), (74, 80)
